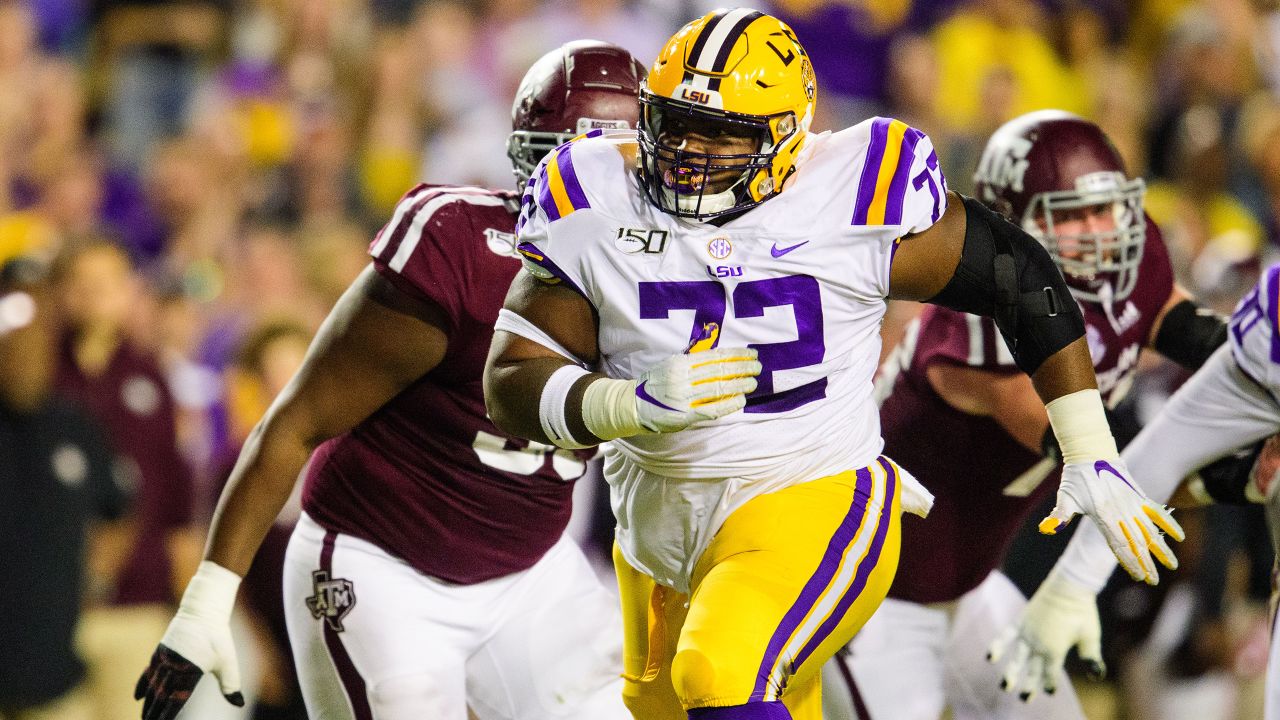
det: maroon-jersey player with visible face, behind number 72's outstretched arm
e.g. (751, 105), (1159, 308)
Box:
(828, 110), (1225, 720)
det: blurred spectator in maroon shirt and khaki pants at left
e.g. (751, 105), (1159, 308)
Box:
(55, 241), (201, 720)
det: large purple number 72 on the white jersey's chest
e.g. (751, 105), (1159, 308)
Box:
(640, 275), (827, 413)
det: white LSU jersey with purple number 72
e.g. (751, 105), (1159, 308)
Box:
(518, 118), (946, 589)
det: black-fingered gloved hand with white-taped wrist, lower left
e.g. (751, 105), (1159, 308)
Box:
(133, 561), (244, 720)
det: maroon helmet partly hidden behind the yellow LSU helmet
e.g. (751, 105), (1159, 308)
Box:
(507, 40), (645, 187)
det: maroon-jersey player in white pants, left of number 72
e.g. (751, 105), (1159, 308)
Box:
(137, 41), (644, 720)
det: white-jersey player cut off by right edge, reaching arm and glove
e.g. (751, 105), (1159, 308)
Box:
(993, 265), (1280, 720)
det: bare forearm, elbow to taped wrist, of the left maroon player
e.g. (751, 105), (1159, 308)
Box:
(205, 415), (315, 577)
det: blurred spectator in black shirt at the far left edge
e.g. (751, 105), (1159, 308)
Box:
(0, 260), (125, 720)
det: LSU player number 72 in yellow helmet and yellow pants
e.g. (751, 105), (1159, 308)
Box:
(485, 9), (1181, 720)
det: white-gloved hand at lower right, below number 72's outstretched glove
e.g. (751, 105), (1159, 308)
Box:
(987, 571), (1107, 702)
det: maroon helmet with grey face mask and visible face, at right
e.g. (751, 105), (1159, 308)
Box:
(974, 110), (1147, 302)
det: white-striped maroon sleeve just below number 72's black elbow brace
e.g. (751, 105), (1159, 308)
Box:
(914, 306), (1020, 374)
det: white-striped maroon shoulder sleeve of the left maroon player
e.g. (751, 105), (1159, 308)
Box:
(369, 184), (513, 331)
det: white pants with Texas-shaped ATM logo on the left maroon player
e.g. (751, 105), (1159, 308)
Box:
(284, 515), (630, 720)
